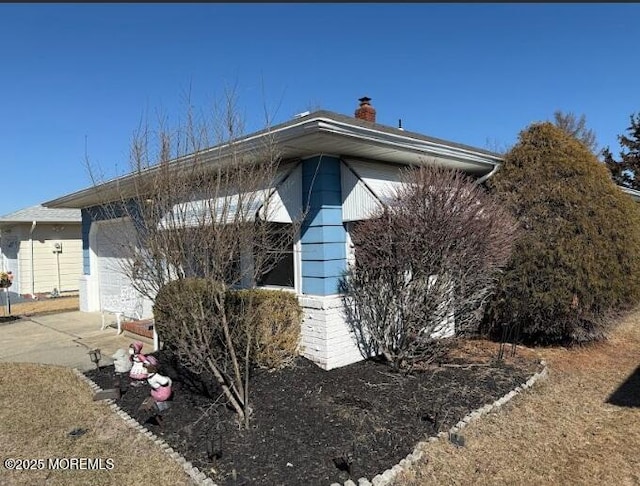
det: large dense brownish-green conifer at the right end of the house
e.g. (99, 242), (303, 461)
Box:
(488, 122), (640, 343)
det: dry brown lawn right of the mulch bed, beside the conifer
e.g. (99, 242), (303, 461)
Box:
(396, 311), (640, 486)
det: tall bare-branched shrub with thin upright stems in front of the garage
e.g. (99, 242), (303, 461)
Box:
(85, 92), (301, 426)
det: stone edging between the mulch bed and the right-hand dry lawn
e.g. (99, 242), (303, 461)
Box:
(331, 360), (549, 486)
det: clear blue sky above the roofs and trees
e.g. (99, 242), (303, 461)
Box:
(0, 4), (640, 215)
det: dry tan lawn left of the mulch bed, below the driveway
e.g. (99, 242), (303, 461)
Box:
(0, 363), (192, 486)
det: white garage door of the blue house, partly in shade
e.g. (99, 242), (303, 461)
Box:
(95, 220), (153, 319)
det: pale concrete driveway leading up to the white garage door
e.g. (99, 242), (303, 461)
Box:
(0, 311), (145, 371)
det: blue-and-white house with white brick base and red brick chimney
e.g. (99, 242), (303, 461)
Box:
(45, 98), (501, 369)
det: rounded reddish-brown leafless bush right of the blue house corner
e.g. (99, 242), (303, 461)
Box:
(342, 167), (516, 369)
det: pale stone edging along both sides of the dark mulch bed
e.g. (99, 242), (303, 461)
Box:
(73, 360), (549, 486)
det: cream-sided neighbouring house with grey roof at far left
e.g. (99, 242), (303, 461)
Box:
(0, 205), (82, 296)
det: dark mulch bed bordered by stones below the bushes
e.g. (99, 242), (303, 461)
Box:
(82, 351), (538, 486)
